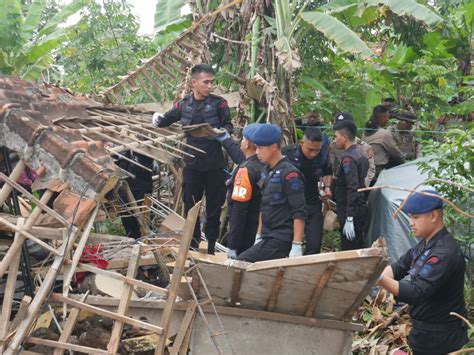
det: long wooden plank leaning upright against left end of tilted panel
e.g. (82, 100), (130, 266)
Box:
(155, 201), (201, 355)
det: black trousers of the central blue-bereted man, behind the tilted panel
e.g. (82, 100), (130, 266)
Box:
(237, 237), (291, 263)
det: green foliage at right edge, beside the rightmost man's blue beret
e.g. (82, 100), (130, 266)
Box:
(419, 125), (474, 255)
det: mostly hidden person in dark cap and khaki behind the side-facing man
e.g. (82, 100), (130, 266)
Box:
(329, 112), (375, 187)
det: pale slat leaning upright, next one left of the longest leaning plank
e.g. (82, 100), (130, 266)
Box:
(107, 245), (140, 355)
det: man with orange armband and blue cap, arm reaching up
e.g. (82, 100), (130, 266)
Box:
(217, 123), (266, 259)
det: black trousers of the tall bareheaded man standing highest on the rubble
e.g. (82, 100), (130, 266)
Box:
(183, 167), (227, 249)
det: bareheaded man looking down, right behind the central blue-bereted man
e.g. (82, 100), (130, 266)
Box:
(282, 127), (332, 255)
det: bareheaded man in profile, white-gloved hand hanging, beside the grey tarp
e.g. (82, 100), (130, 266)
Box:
(334, 120), (369, 250)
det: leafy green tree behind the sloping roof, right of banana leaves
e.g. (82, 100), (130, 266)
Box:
(58, 0), (159, 94)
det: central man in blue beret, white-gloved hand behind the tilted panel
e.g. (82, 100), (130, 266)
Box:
(238, 124), (306, 262)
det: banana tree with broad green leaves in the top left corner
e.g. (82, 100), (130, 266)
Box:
(0, 0), (90, 80)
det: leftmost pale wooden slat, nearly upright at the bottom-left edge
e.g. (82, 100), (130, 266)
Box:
(0, 218), (24, 353)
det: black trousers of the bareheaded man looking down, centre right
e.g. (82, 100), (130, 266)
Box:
(304, 202), (324, 255)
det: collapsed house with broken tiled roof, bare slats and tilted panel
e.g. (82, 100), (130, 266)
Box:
(0, 2), (387, 354)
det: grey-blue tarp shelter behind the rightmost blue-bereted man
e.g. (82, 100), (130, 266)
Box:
(365, 158), (429, 262)
